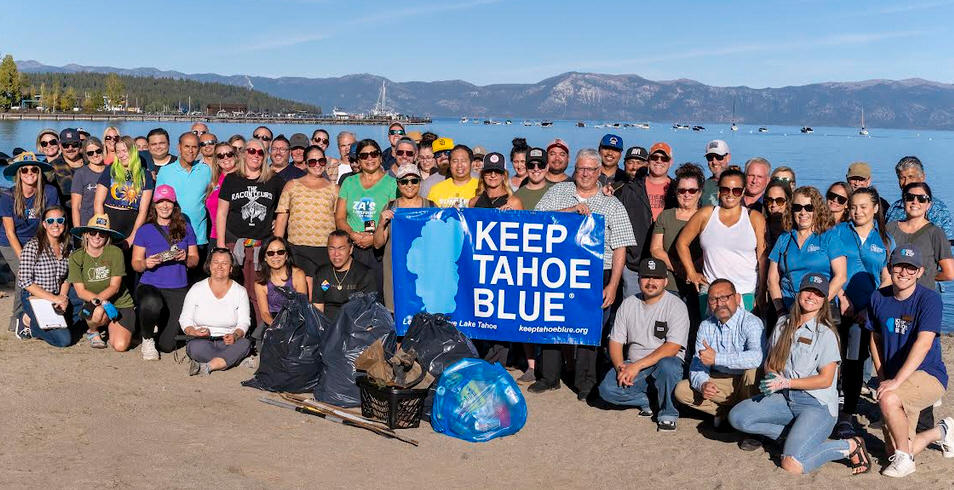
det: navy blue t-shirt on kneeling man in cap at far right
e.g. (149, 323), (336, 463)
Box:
(865, 284), (947, 388)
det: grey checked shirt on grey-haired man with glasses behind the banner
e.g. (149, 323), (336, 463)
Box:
(534, 182), (636, 270)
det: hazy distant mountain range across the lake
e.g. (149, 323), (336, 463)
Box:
(17, 61), (954, 129)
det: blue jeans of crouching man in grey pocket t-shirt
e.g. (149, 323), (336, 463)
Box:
(600, 357), (682, 422)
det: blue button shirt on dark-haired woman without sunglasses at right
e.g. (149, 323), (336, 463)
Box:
(831, 221), (894, 311)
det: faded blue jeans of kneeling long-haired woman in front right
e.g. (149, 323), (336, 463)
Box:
(729, 390), (850, 473)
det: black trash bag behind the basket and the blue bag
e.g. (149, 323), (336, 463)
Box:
(401, 312), (480, 418)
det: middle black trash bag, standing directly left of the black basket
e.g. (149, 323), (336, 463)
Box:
(315, 292), (396, 408)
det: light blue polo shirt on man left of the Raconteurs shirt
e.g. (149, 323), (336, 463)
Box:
(156, 161), (212, 245)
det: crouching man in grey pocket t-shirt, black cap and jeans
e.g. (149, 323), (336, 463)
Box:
(600, 259), (689, 432)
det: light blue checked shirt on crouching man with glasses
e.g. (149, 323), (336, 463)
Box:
(689, 305), (765, 391)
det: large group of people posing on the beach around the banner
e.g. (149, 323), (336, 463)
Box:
(0, 123), (954, 477)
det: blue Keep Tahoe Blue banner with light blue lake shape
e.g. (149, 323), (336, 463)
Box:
(391, 208), (604, 345)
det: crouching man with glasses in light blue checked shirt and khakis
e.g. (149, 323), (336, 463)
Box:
(676, 279), (765, 430)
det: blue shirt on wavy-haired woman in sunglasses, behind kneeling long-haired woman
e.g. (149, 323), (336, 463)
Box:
(769, 229), (845, 308)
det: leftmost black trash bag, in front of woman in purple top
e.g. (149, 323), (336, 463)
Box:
(242, 288), (331, 393)
